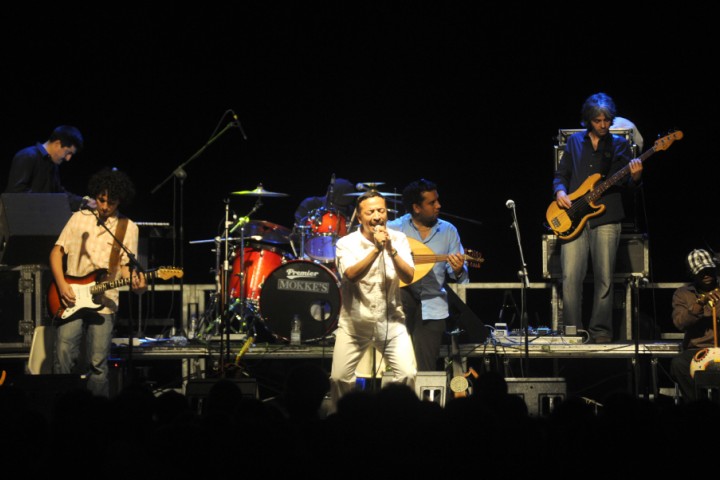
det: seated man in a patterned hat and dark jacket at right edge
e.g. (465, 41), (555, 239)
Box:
(670, 250), (720, 402)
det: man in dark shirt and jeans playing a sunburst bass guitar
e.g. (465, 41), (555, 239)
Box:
(553, 93), (642, 343)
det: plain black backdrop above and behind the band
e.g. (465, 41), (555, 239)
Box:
(0, 2), (720, 334)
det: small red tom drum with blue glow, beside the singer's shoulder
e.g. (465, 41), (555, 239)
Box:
(305, 208), (348, 263)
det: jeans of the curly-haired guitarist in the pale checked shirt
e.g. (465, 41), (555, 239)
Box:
(55, 314), (115, 397)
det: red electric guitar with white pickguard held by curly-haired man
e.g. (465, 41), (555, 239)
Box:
(47, 267), (183, 325)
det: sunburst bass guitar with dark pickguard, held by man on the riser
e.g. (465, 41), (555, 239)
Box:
(545, 131), (683, 240)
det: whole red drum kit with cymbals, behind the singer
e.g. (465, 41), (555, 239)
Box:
(190, 180), (399, 344)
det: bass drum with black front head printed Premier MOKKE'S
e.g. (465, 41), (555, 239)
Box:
(260, 260), (340, 343)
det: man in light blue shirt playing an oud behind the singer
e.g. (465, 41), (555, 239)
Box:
(387, 179), (470, 372)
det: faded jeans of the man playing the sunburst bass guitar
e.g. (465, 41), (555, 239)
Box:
(560, 223), (621, 338)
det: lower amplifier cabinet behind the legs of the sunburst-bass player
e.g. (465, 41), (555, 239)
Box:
(542, 233), (650, 281)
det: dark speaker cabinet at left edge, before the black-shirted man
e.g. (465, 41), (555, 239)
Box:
(0, 193), (72, 266)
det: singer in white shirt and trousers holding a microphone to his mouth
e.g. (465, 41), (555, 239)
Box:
(330, 190), (417, 411)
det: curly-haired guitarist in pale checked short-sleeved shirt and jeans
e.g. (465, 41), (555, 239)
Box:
(50, 169), (146, 397)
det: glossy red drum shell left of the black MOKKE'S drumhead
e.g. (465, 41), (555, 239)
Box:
(229, 243), (291, 302)
